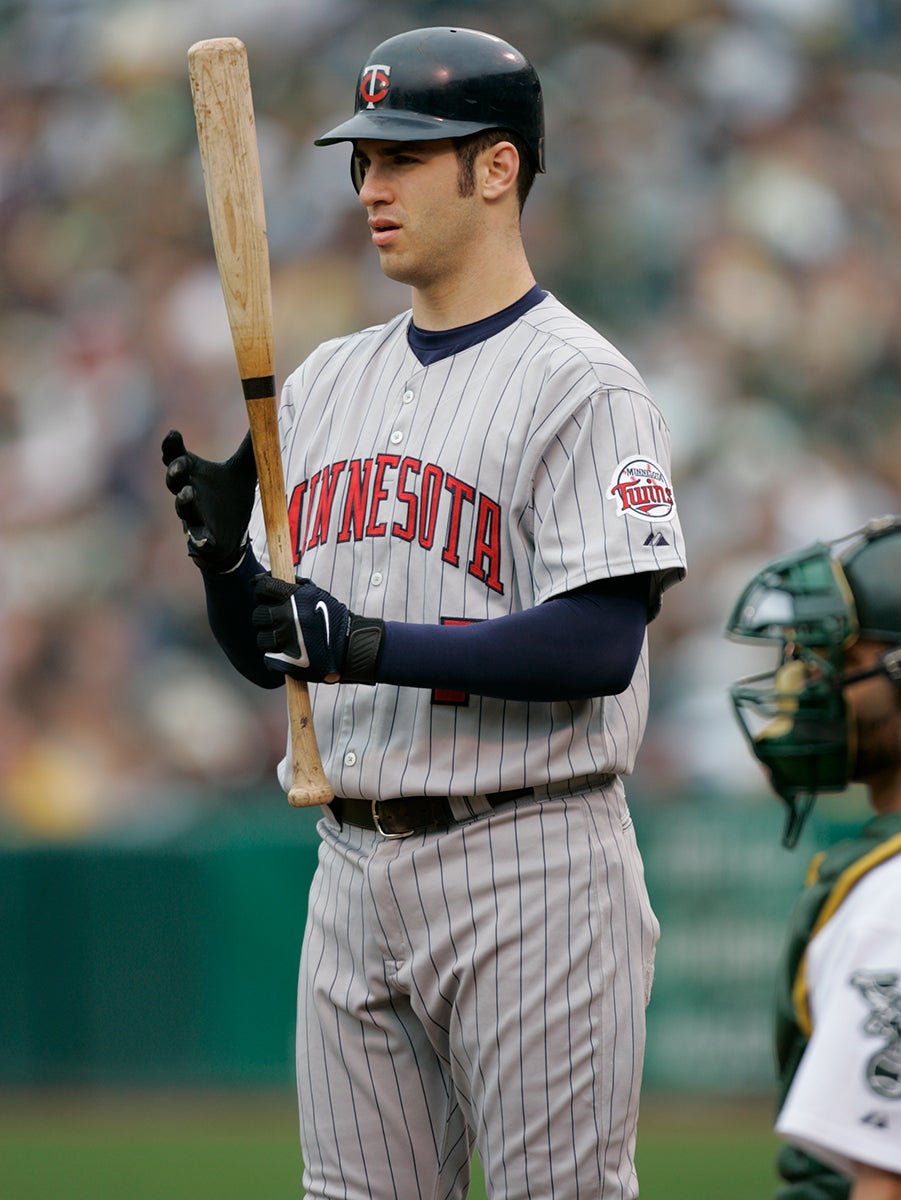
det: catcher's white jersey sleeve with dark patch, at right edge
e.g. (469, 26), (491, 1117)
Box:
(776, 856), (901, 1176)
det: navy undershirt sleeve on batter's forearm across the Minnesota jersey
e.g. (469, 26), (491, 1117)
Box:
(377, 575), (650, 701)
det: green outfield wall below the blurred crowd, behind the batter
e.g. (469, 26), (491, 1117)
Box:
(0, 796), (873, 1092)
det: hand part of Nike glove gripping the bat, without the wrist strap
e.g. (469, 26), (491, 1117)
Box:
(251, 572), (350, 683)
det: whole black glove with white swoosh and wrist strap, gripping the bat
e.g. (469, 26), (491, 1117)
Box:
(251, 572), (385, 683)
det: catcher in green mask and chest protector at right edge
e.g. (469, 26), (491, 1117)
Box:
(727, 516), (901, 1200)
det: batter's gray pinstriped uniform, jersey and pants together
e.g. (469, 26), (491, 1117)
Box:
(251, 296), (685, 1200)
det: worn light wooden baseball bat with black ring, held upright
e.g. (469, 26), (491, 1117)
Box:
(187, 37), (334, 808)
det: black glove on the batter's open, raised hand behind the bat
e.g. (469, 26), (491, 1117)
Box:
(162, 430), (257, 572)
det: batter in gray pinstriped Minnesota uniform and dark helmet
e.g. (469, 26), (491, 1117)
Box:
(163, 28), (685, 1200)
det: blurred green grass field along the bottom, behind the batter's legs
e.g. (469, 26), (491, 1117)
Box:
(0, 1093), (776, 1200)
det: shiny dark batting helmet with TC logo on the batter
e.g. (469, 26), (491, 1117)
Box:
(314, 28), (545, 172)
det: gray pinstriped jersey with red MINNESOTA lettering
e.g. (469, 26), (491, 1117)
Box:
(251, 295), (685, 798)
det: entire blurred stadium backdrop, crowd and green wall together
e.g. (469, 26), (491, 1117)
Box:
(0, 0), (901, 1200)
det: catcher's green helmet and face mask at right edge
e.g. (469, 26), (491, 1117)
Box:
(726, 516), (901, 846)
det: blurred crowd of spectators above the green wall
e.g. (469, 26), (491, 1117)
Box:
(0, 0), (901, 840)
